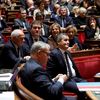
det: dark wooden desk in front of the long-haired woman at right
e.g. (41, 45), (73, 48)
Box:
(85, 39), (100, 49)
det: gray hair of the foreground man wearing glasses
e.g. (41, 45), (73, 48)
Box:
(30, 41), (50, 54)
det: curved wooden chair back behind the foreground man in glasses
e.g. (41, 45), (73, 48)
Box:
(15, 64), (43, 100)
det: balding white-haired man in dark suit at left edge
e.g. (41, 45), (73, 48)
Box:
(0, 29), (29, 69)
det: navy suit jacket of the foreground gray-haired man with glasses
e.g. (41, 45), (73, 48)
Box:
(20, 58), (66, 100)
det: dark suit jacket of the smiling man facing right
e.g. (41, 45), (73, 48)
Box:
(47, 48), (81, 77)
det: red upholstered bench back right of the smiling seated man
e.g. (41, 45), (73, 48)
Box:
(74, 55), (100, 81)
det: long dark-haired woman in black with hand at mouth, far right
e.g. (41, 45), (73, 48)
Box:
(84, 16), (100, 40)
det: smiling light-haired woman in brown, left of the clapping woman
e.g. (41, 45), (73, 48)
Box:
(48, 23), (61, 50)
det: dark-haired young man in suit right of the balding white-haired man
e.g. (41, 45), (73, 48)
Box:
(24, 20), (47, 53)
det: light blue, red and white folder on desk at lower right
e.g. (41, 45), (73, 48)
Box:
(77, 82), (100, 91)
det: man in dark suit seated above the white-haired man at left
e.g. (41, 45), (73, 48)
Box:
(14, 9), (30, 31)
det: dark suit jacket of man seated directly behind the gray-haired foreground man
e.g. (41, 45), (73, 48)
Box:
(23, 33), (47, 54)
